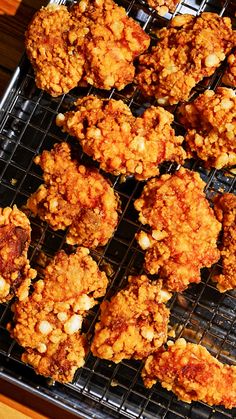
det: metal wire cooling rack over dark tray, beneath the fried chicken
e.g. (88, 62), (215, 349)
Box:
(0, 0), (236, 419)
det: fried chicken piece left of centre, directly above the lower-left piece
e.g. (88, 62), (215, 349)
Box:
(27, 143), (118, 247)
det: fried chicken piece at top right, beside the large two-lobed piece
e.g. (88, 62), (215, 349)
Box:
(136, 13), (235, 105)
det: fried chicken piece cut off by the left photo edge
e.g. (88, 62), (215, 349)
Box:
(0, 205), (36, 303)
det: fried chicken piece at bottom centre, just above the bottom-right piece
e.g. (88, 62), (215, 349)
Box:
(91, 275), (171, 363)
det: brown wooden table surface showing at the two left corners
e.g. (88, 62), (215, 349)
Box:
(0, 4), (79, 419)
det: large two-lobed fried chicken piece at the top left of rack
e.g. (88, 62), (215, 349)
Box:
(25, 0), (149, 96)
